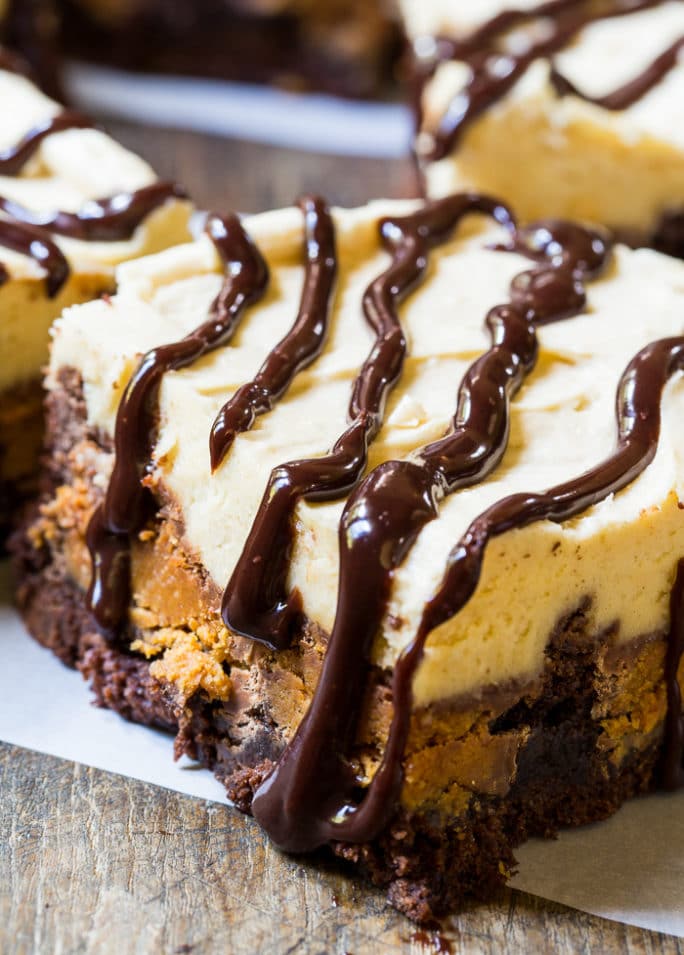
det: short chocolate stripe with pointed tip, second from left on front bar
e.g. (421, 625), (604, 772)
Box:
(209, 196), (337, 470)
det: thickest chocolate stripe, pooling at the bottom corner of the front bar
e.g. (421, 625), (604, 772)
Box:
(252, 213), (609, 851)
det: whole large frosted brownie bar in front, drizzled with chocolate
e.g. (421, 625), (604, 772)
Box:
(14, 194), (684, 920)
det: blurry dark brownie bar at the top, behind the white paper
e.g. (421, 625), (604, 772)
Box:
(57, 0), (406, 96)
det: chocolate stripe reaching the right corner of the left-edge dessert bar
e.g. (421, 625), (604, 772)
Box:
(0, 182), (187, 242)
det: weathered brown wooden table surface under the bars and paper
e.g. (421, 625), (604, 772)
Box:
(0, 123), (684, 955)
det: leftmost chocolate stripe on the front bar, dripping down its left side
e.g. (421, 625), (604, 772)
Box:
(87, 215), (269, 638)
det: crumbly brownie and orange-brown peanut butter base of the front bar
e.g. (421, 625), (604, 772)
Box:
(12, 374), (680, 922)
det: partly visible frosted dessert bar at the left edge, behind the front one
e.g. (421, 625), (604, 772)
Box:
(0, 56), (191, 525)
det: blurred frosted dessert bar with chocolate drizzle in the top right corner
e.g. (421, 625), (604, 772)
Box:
(402, 0), (684, 255)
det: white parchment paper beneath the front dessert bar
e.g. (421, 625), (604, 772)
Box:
(0, 567), (684, 937)
